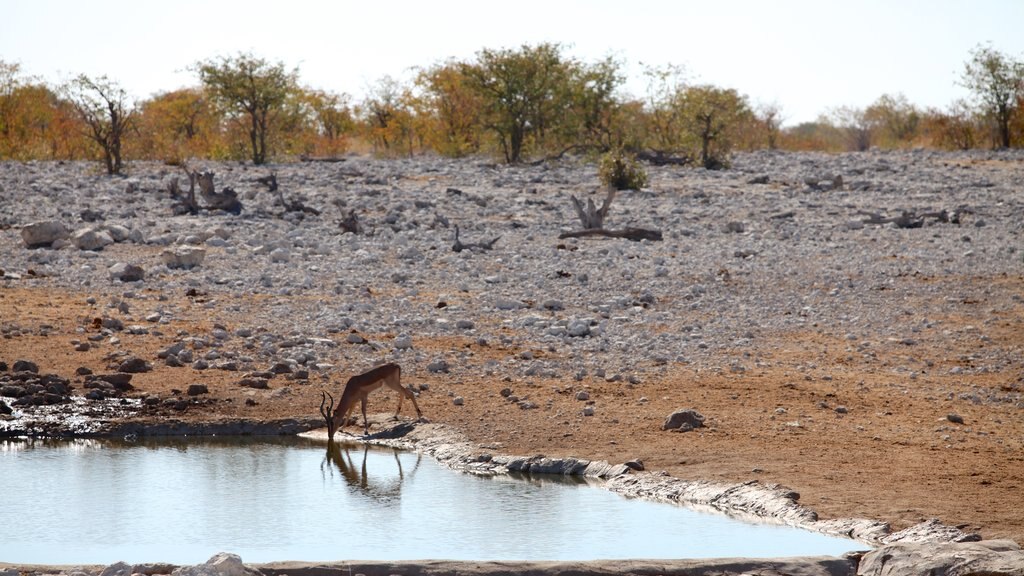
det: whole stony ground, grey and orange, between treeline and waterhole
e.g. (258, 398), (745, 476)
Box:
(0, 151), (1024, 553)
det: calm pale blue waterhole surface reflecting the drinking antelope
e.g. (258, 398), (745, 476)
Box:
(0, 439), (864, 564)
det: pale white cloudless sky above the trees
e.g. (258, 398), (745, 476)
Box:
(0, 0), (1024, 124)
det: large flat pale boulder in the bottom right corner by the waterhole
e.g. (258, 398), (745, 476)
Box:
(857, 540), (1024, 576)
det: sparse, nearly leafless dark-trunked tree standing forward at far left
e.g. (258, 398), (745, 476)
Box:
(63, 74), (135, 174)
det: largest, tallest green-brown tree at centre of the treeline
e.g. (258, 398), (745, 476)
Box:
(461, 43), (574, 164)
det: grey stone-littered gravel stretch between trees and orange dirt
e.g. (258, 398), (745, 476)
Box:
(0, 151), (1024, 382)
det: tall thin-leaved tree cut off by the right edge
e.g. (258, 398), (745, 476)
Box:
(961, 45), (1024, 148)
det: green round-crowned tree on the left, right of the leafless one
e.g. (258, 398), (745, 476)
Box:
(195, 53), (298, 165)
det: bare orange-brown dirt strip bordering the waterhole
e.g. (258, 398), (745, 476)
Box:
(0, 276), (1024, 542)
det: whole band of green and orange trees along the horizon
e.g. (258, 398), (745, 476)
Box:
(0, 43), (1024, 173)
